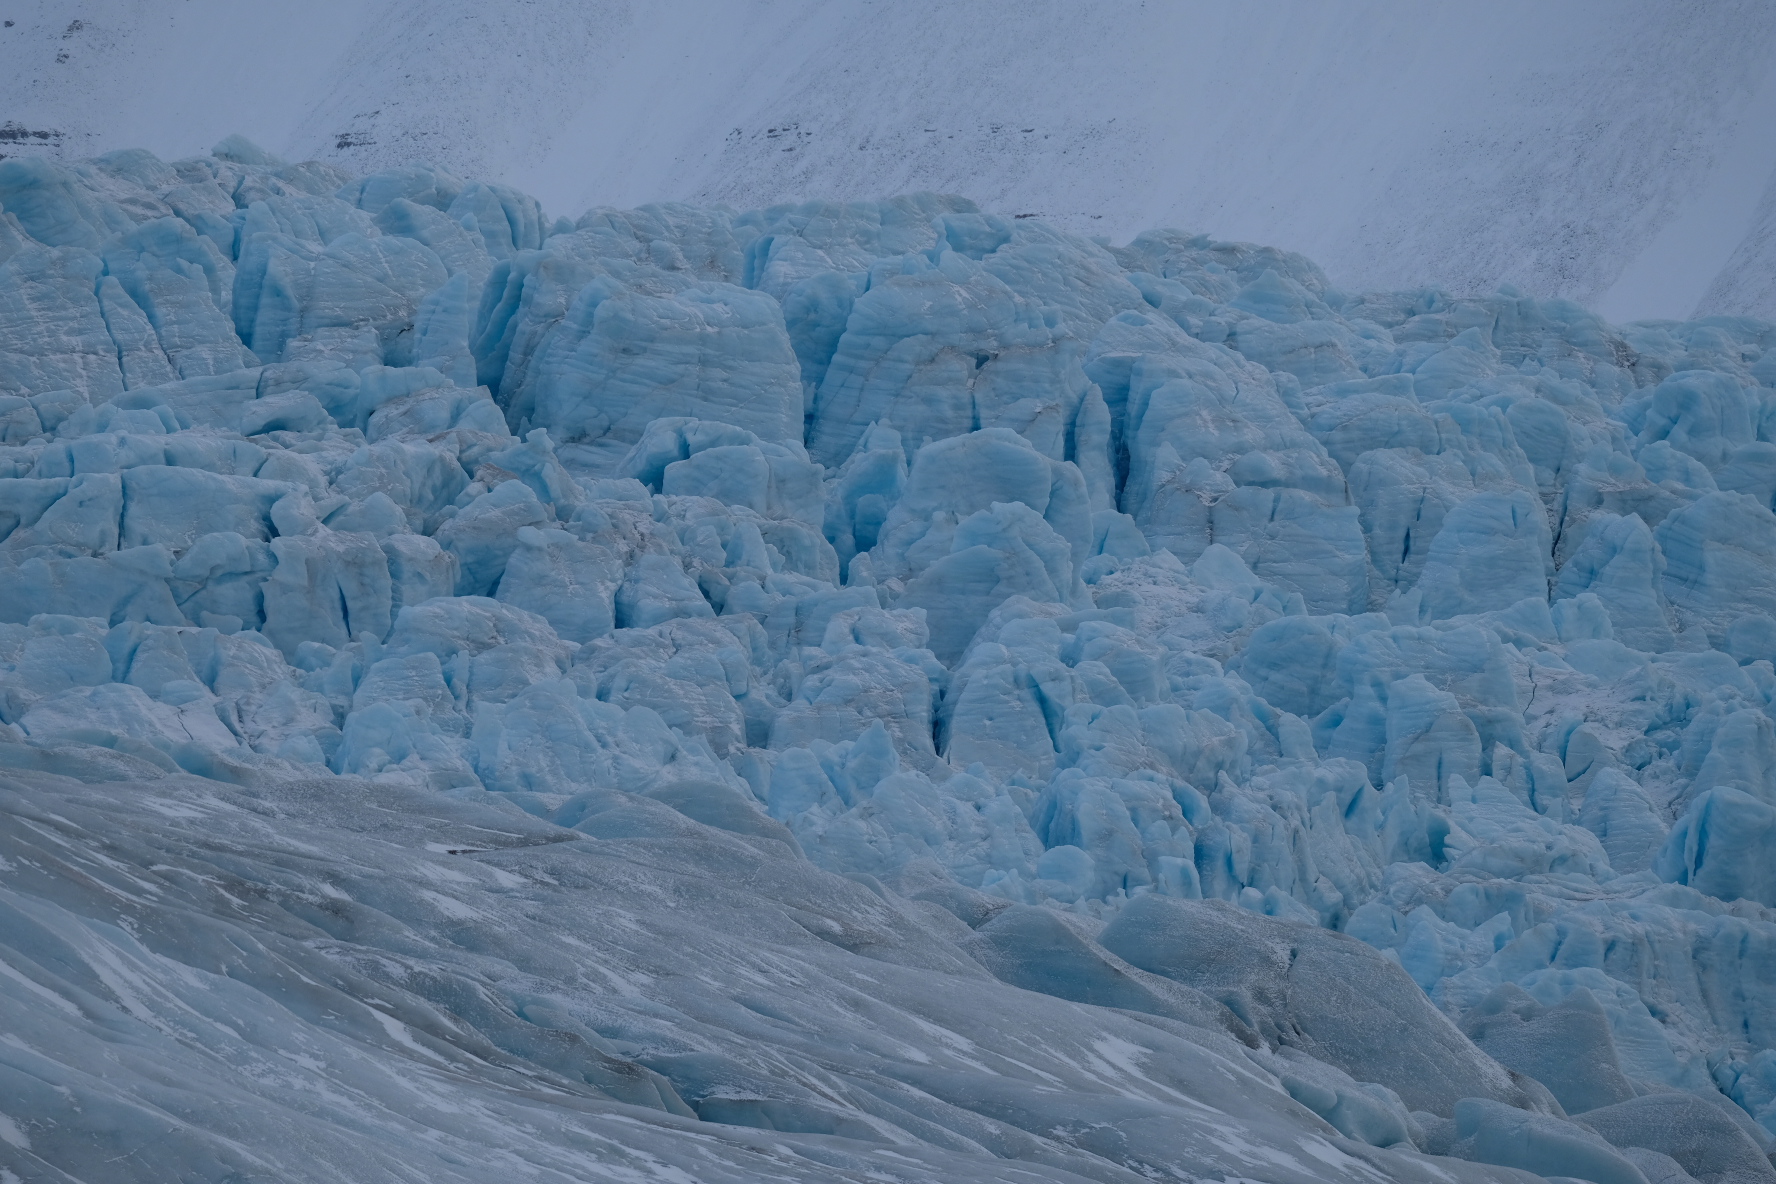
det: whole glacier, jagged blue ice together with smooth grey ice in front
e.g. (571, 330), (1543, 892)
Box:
(0, 137), (1776, 1184)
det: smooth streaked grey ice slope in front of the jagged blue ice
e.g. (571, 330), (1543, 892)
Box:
(0, 744), (1541, 1184)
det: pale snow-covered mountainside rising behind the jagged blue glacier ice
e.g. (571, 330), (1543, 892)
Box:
(0, 0), (1776, 321)
